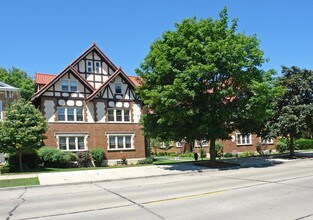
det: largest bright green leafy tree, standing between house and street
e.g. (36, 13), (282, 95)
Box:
(136, 8), (266, 160)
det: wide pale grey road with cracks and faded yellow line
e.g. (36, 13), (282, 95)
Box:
(0, 159), (313, 220)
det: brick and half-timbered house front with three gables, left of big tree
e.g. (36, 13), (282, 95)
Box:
(32, 44), (146, 164)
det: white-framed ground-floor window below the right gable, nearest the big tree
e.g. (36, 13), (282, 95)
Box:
(108, 134), (134, 150)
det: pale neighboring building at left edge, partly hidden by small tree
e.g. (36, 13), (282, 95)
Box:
(0, 82), (20, 164)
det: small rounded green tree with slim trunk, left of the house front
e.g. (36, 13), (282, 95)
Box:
(0, 99), (47, 170)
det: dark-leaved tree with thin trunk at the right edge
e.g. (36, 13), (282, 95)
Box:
(269, 66), (313, 156)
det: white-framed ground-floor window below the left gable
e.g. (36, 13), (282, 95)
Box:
(57, 134), (87, 151)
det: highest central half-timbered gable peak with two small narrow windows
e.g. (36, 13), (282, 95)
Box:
(71, 44), (117, 88)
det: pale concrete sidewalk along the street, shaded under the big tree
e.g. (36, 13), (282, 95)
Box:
(0, 153), (312, 185)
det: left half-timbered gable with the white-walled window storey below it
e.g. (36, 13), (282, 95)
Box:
(32, 67), (93, 122)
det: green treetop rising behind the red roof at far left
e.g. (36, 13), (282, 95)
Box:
(0, 67), (35, 100)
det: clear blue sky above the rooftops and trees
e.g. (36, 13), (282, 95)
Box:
(0, 0), (313, 77)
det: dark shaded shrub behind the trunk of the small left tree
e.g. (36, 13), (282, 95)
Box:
(8, 151), (40, 171)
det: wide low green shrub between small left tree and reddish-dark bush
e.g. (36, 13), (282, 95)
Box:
(38, 147), (78, 168)
